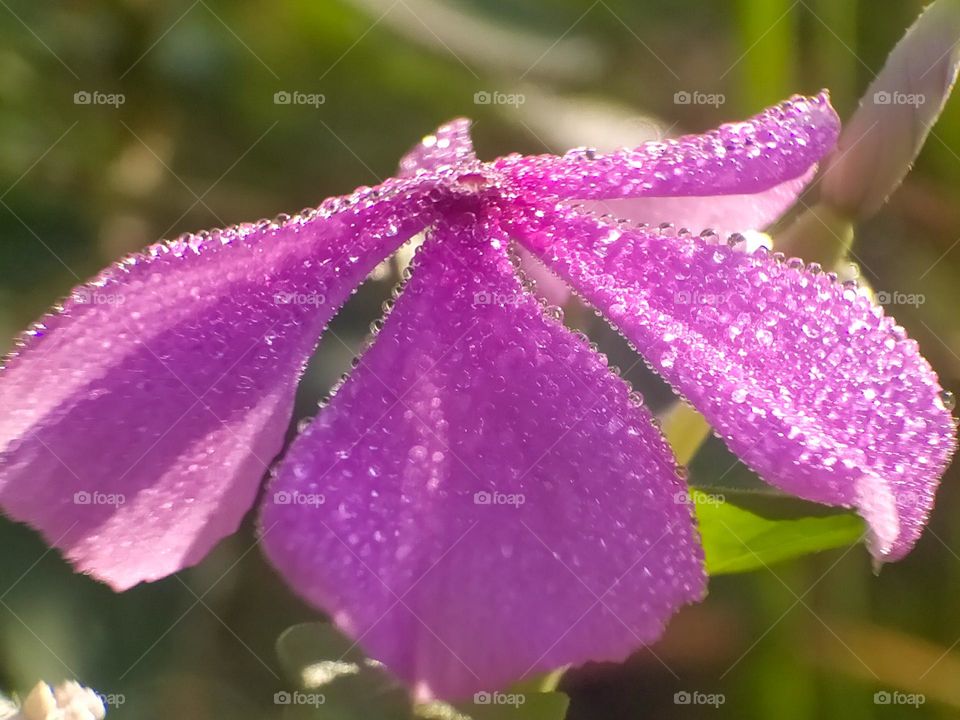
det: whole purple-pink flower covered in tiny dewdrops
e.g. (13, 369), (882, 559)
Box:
(0, 95), (955, 697)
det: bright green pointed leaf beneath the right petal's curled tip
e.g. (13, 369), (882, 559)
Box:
(692, 490), (865, 575)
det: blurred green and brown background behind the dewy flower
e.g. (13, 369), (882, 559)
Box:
(0, 0), (960, 720)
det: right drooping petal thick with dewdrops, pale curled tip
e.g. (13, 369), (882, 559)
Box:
(506, 206), (956, 560)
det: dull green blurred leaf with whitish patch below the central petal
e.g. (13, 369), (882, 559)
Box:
(275, 622), (413, 720)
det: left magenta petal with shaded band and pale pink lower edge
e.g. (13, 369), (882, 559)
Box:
(0, 177), (425, 588)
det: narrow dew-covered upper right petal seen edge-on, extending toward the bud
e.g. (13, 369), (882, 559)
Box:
(493, 93), (840, 201)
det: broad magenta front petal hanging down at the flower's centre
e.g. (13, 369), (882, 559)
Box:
(262, 217), (705, 697)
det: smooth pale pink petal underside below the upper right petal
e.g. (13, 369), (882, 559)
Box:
(583, 166), (817, 235)
